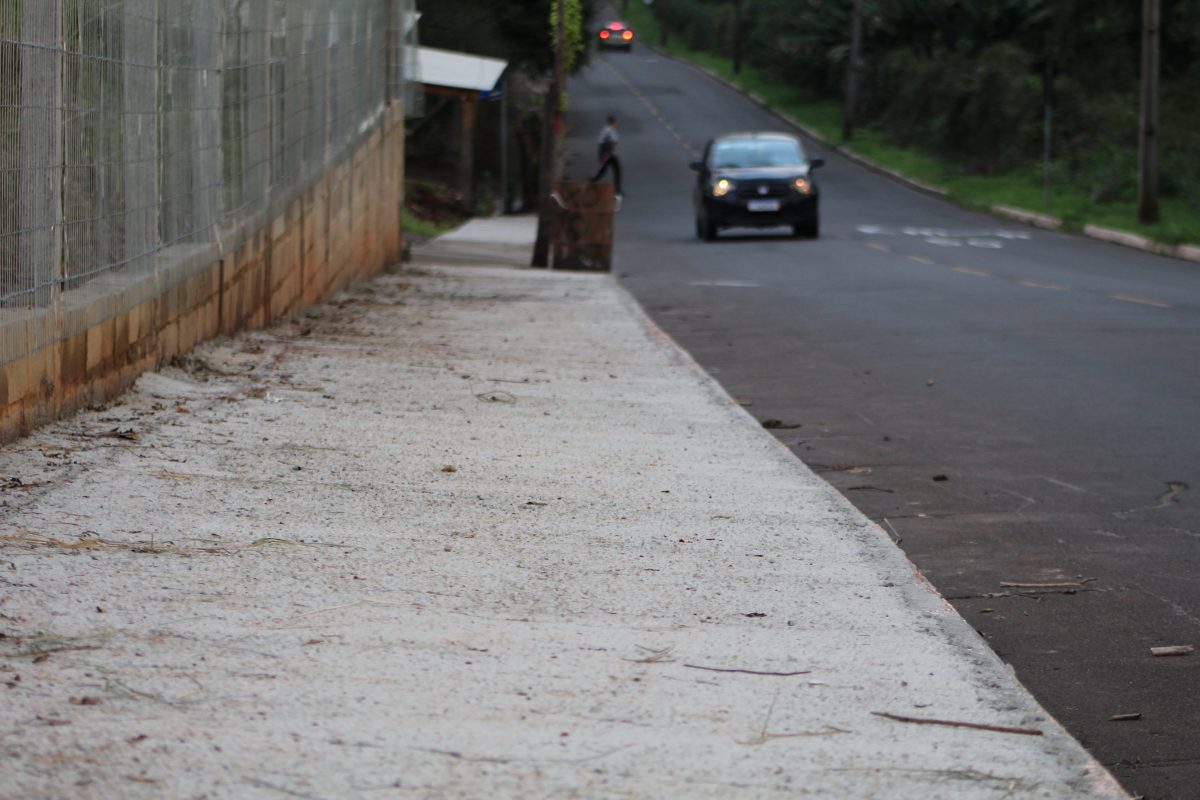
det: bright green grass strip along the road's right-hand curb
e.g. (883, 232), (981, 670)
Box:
(625, 0), (1200, 245)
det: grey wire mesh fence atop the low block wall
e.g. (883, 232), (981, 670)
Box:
(0, 0), (419, 362)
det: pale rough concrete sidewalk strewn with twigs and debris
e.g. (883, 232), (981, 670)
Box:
(0, 215), (1126, 800)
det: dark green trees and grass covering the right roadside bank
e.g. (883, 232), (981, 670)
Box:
(625, 0), (1200, 243)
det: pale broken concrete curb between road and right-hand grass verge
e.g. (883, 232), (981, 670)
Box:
(642, 43), (1200, 264)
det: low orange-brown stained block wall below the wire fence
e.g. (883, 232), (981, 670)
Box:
(0, 107), (404, 441)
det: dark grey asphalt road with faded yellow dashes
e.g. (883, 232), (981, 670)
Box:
(568, 47), (1200, 799)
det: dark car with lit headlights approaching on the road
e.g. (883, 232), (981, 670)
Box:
(691, 132), (824, 241)
